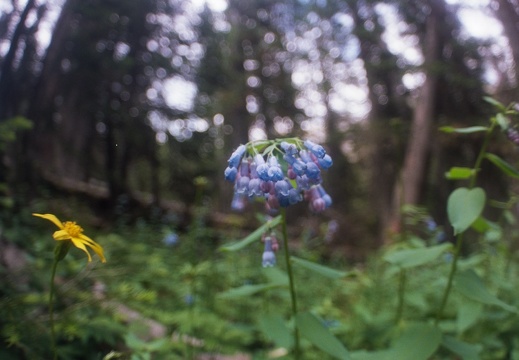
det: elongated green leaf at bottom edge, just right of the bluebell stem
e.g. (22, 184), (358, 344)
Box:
(296, 312), (350, 360)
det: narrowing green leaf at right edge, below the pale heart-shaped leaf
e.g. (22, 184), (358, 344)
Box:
(454, 269), (517, 313)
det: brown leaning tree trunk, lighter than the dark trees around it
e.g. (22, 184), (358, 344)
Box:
(395, 2), (443, 208)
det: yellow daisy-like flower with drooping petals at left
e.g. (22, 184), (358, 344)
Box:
(32, 214), (106, 262)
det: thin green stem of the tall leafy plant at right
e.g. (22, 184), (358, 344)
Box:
(435, 119), (497, 325)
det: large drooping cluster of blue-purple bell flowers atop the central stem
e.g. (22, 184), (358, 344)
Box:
(224, 138), (333, 212)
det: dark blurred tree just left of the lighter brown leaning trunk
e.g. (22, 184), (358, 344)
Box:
(351, 2), (410, 244)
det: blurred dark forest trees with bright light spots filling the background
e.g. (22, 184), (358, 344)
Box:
(0, 0), (519, 250)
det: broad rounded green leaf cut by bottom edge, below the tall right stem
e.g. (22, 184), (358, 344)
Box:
(391, 324), (442, 360)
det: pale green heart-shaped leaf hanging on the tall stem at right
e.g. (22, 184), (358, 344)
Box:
(447, 188), (486, 235)
